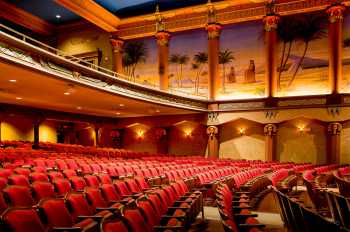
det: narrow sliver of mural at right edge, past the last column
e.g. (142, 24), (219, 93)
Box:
(340, 15), (350, 93)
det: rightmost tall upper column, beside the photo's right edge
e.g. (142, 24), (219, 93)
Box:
(327, 3), (346, 94)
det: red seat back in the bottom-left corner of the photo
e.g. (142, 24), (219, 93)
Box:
(2, 208), (48, 232)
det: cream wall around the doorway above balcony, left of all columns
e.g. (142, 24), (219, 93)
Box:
(57, 28), (113, 69)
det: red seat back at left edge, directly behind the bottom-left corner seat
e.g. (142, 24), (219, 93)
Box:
(3, 185), (35, 207)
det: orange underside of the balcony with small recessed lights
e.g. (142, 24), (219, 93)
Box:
(0, 59), (196, 118)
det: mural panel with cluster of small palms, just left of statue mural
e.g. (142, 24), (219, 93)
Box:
(169, 30), (208, 96)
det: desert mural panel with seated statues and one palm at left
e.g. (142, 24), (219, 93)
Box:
(219, 21), (265, 99)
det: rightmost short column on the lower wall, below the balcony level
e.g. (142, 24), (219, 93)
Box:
(327, 122), (343, 164)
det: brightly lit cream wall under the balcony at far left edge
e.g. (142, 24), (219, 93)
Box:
(1, 117), (34, 141)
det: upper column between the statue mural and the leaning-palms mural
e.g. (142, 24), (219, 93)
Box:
(263, 14), (280, 98)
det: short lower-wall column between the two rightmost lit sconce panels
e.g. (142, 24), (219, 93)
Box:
(264, 124), (277, 161)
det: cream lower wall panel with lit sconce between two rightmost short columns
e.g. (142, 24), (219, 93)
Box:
(277, 119), (327, 164)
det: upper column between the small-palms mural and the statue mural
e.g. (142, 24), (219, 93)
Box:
(206, 23), (222, 101)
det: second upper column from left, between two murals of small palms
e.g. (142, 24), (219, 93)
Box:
(155, 31), (170, 91)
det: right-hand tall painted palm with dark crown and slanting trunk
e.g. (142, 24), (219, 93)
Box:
(288, 14), (327, 86)
